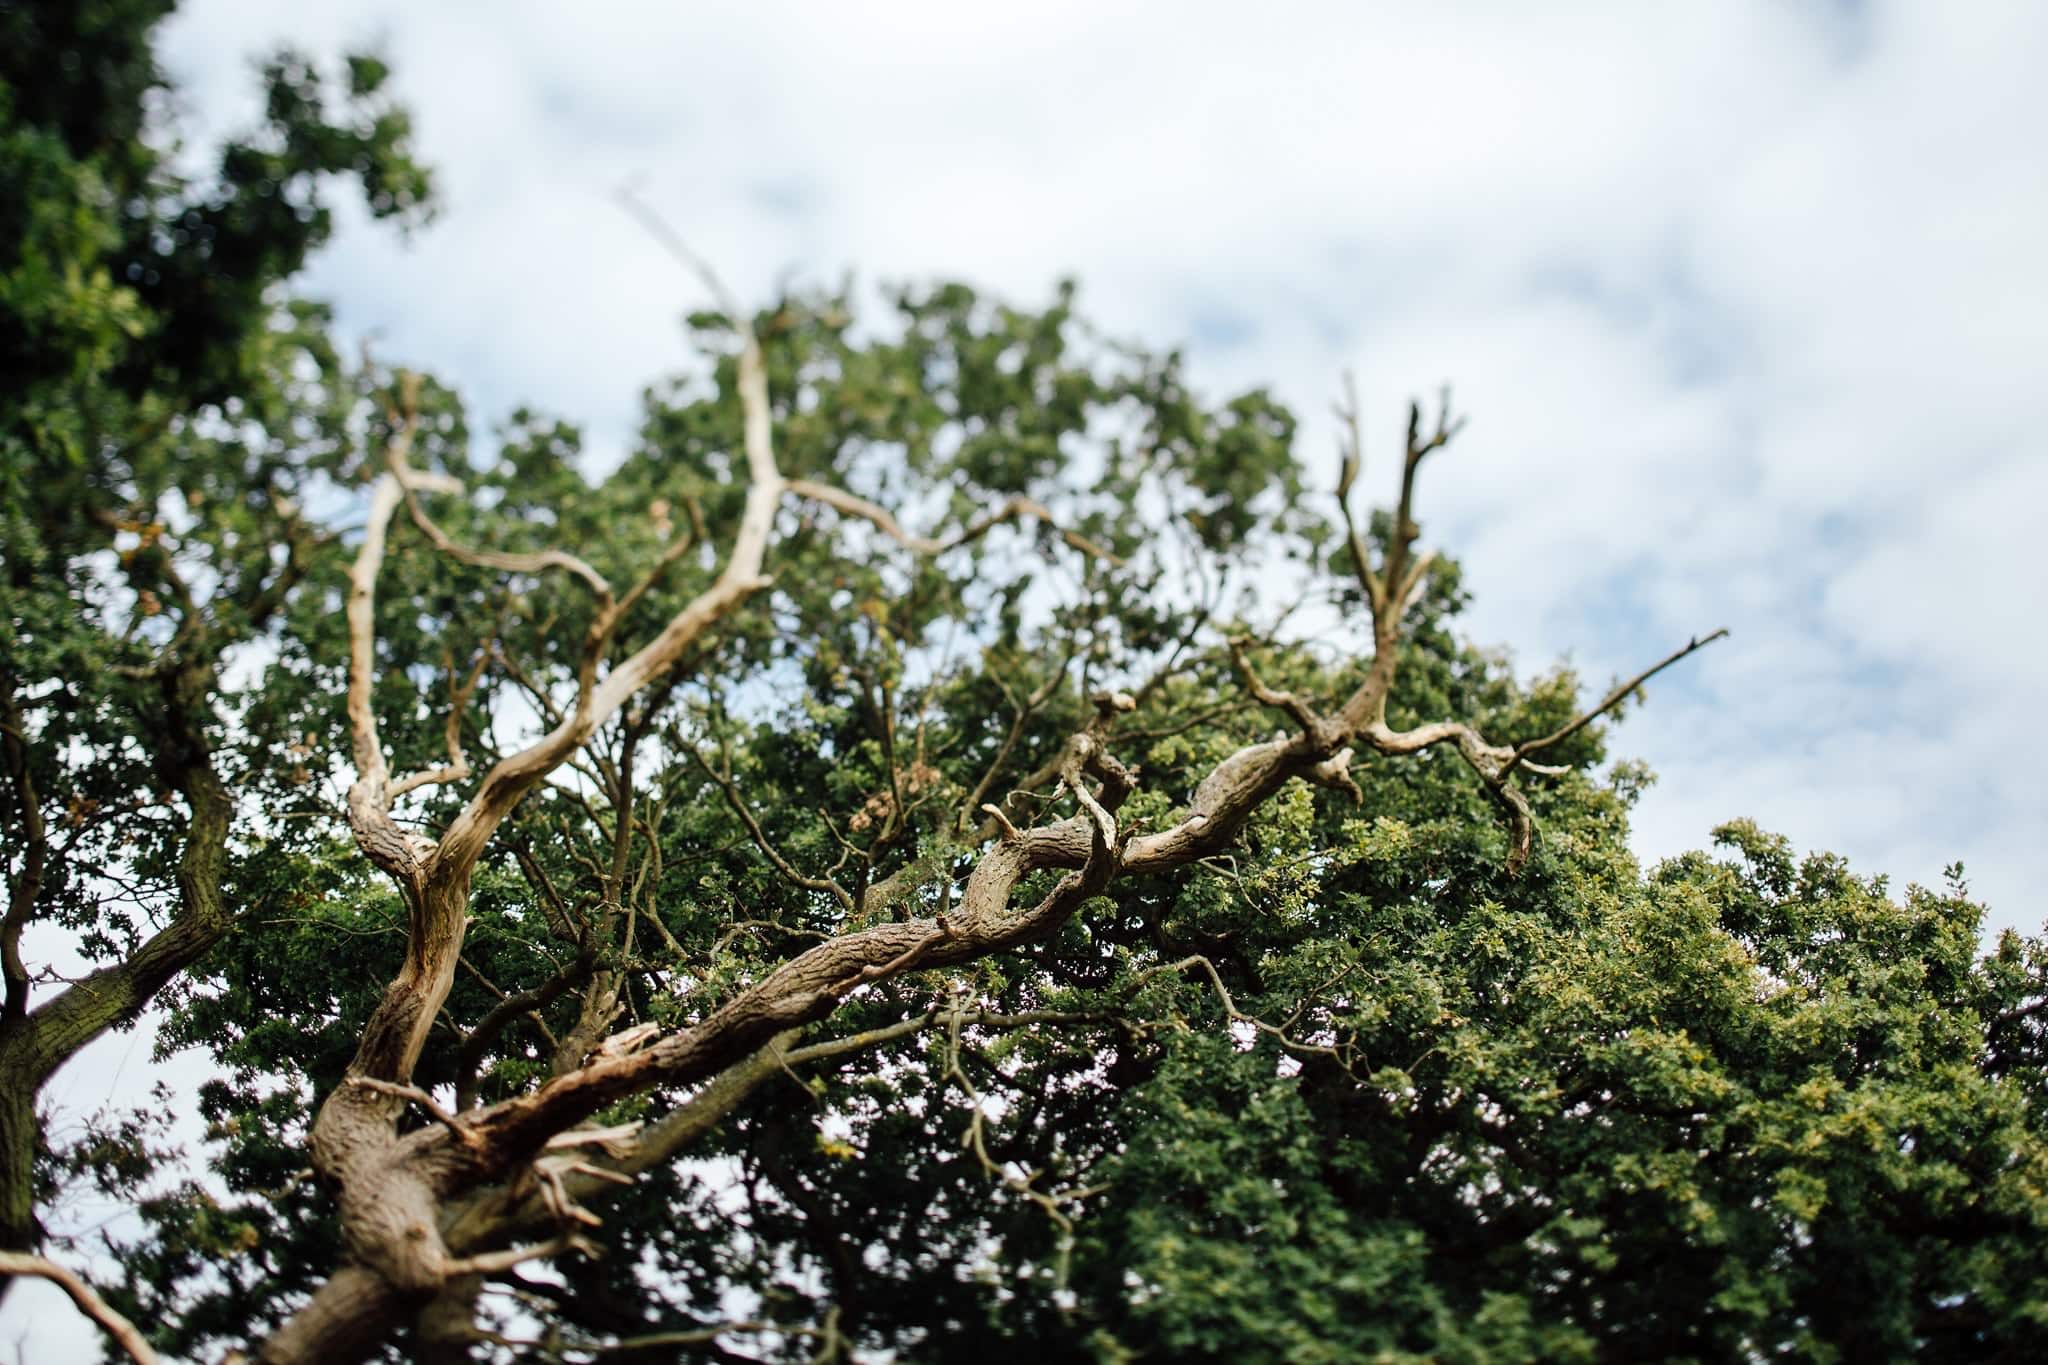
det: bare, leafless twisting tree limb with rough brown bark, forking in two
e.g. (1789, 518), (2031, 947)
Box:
(258, 307), (1718, 1365)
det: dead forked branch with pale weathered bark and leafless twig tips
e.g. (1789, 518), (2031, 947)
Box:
(272, 280), (1724, 1359)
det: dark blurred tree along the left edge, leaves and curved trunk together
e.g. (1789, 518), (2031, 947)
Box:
(0, 0), (428, 1277)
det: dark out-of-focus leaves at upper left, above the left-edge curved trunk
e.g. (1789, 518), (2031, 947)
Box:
(0, 0), (426, 970)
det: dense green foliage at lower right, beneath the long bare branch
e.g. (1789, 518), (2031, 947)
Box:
(561, 657), (2048, 1361)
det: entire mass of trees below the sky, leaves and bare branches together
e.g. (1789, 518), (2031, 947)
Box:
(12, 4), (2048, 1363)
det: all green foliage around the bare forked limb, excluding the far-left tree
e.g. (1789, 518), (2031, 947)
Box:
(112, 272), (2048, 1361)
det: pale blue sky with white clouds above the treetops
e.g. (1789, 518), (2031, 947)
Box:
(0, 0), (2048, 1359)
